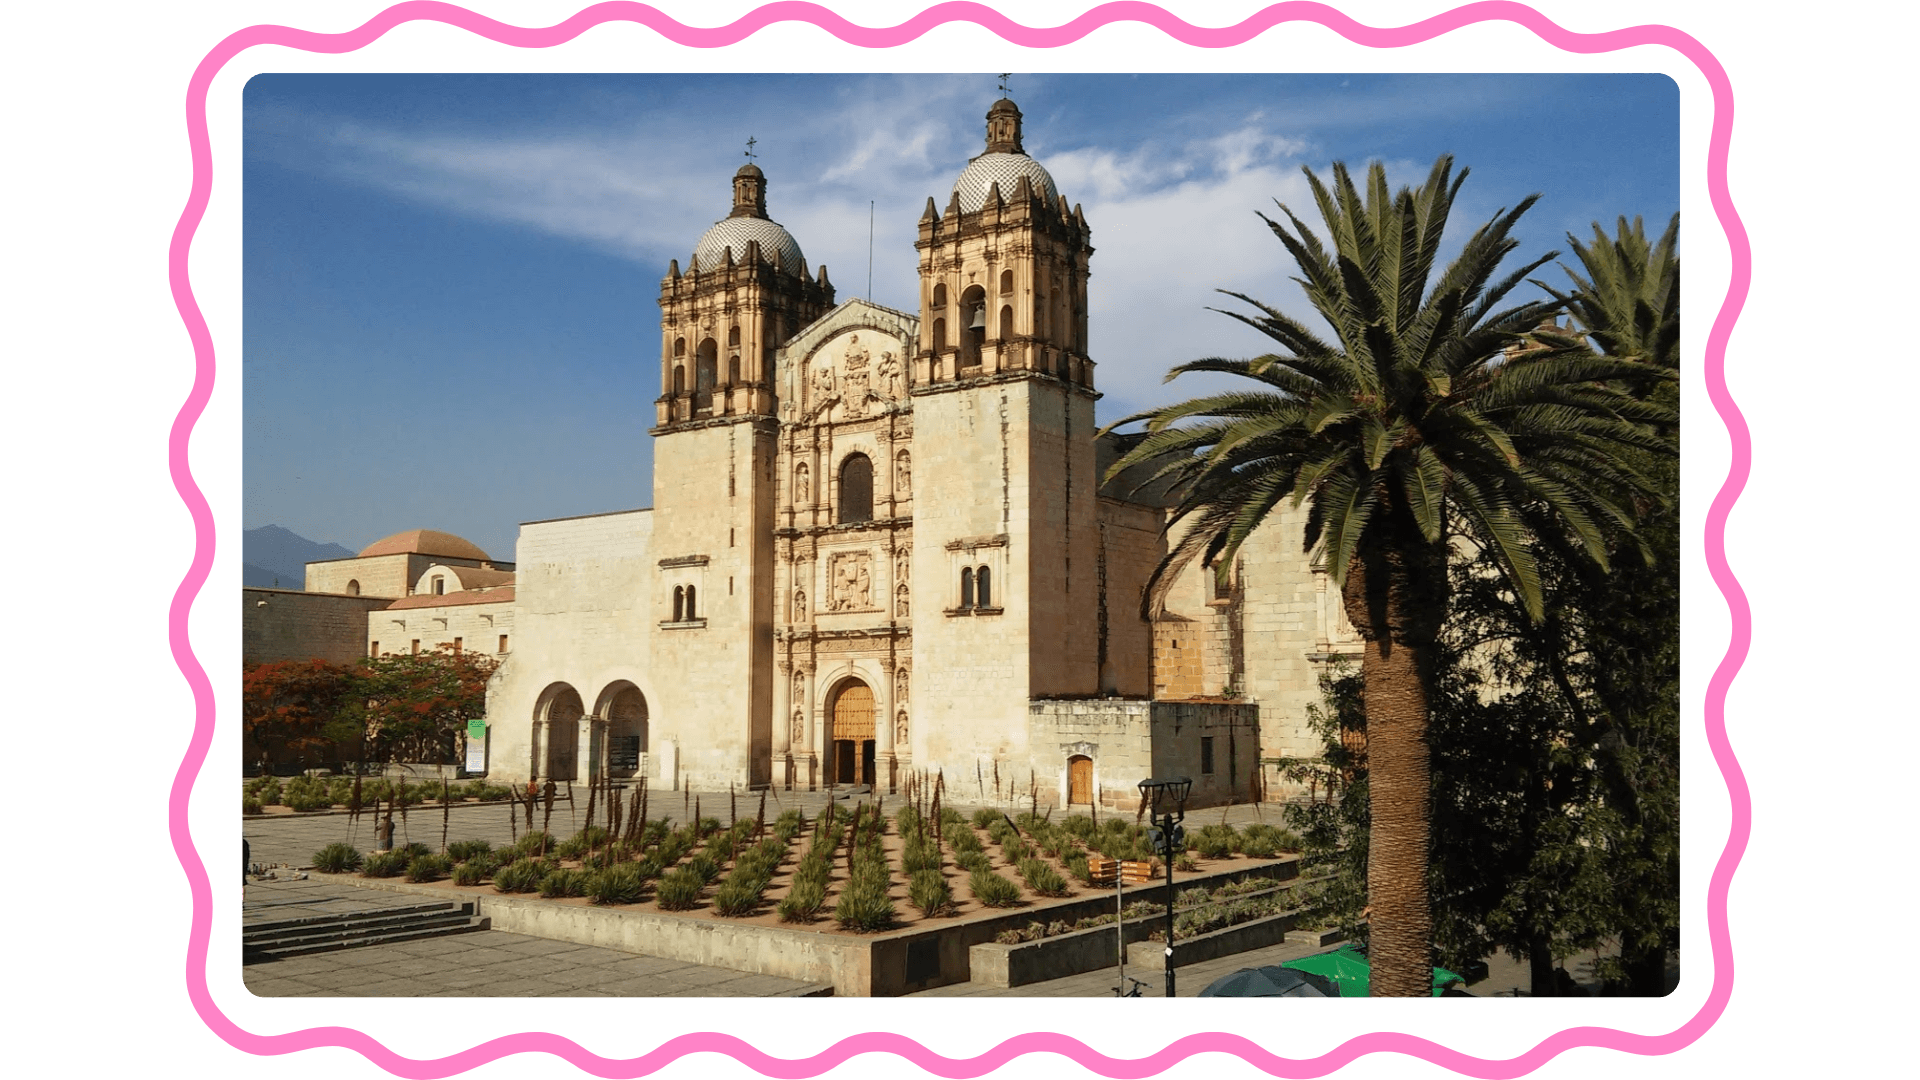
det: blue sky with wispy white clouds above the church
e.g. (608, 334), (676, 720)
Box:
(242, 73), (1680, 559)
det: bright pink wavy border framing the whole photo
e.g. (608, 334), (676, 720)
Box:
(167, 0), (1753, 1080)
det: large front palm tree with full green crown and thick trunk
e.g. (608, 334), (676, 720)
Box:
(1110, 156), (1672, 997)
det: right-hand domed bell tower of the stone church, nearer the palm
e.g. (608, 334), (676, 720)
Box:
(912, 98), (1100, 773)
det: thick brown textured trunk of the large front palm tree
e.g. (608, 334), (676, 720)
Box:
(1361, 632), (1432, 997)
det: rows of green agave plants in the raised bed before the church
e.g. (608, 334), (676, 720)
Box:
(313, 776), (1292, 930)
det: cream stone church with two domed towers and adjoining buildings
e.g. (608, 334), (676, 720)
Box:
(270, 98), (1357, 809)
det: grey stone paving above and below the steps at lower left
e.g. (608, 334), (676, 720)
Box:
(240, 871), (831, 997)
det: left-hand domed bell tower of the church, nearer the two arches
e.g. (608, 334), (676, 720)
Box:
(649, 163), (833, 788)
